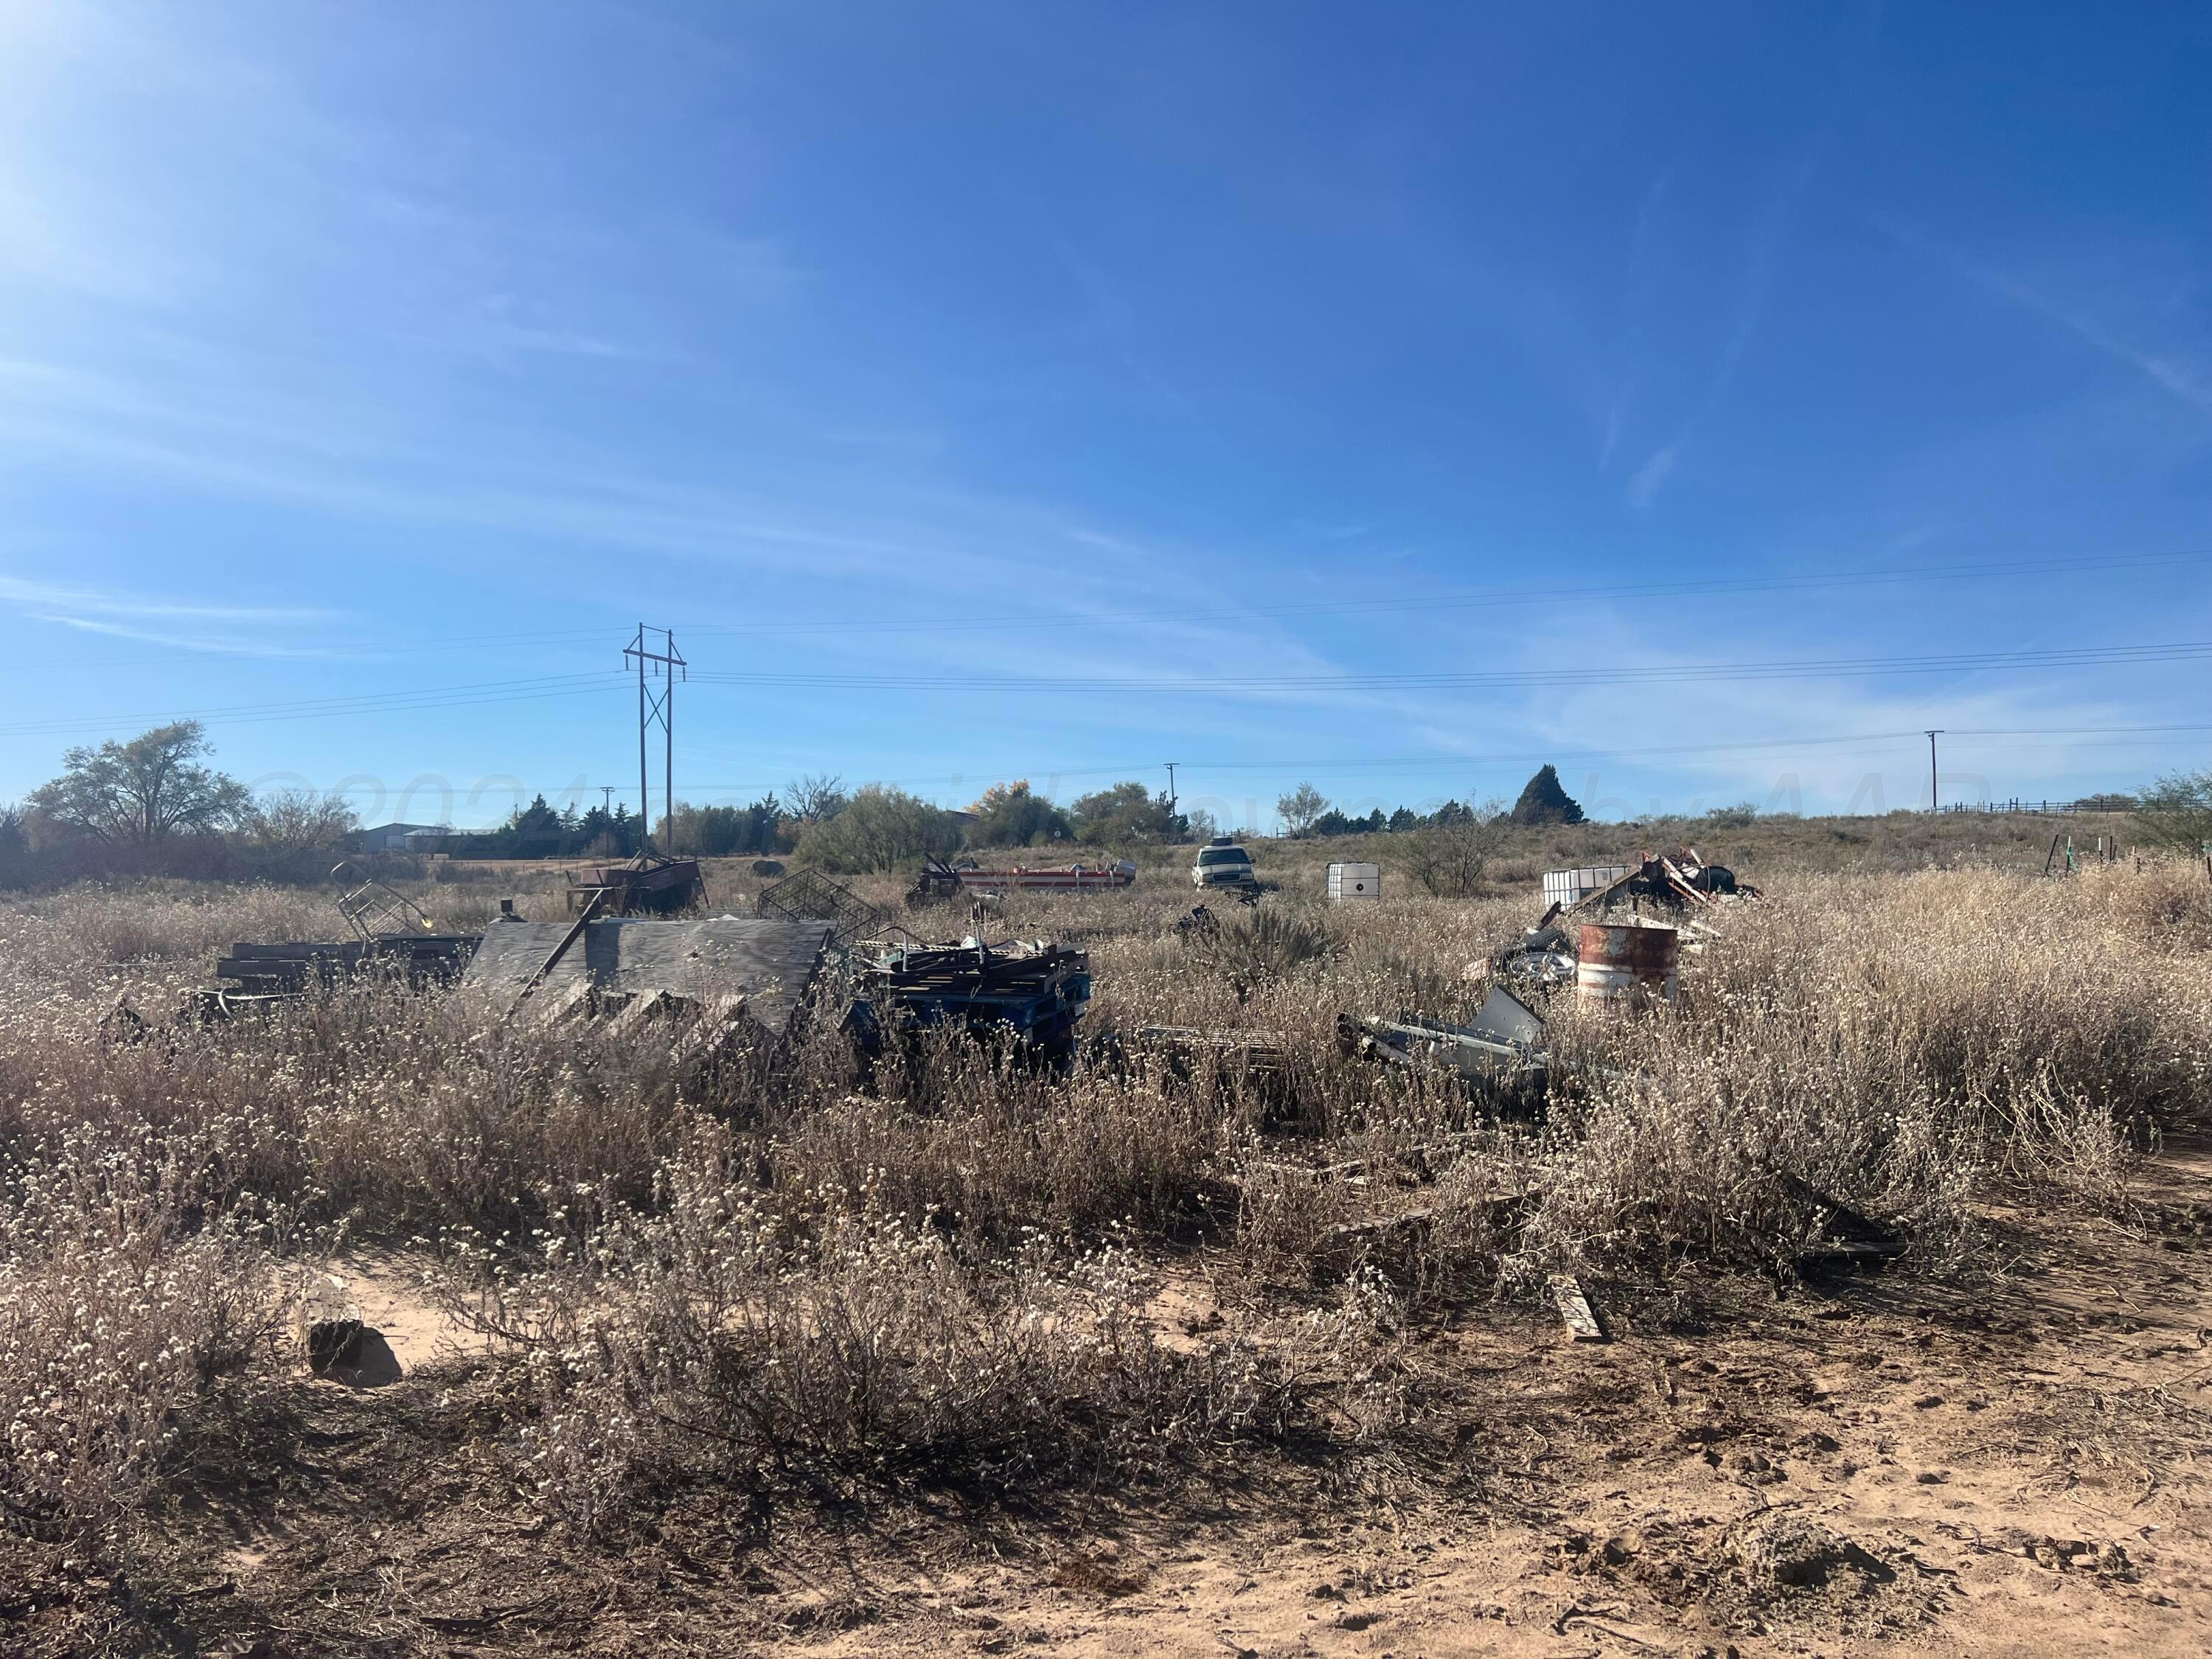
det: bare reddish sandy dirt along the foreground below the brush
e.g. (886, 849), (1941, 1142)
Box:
(13, 1148), (2212, 1659)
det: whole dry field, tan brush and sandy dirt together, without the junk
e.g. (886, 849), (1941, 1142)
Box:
(0, 818), (2212, 1659)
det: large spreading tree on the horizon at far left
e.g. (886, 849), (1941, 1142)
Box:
(24, 721), (252, 845)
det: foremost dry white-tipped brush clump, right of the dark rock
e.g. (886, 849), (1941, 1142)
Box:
(422, 1161), (1405, 1531)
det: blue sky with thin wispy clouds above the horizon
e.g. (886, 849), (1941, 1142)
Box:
(0, 0), (2212, 827)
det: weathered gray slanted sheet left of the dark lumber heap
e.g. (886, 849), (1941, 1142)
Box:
(462, 916), (832, 1033)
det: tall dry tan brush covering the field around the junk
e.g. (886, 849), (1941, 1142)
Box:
(0, 867), (2212, 1537)
